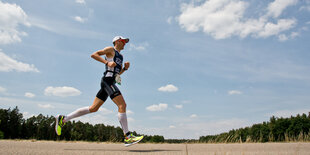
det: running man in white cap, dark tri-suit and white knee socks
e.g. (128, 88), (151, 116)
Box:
(55, 36), (143, 146)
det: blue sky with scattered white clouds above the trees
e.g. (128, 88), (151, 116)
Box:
(0, 0), (310, 139)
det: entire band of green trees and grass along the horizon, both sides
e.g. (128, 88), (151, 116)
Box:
(0, 107), (310, 143)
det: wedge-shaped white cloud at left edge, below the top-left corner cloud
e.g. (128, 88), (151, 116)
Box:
(0, 49), (39, 72)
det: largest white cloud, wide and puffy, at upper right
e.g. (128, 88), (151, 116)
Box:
(178, 0), (297, 39)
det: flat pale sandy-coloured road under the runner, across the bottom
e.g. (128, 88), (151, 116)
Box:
(0, 140), (310, 155)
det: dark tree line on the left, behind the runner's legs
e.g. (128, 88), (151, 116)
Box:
(0, 107), (164, 143)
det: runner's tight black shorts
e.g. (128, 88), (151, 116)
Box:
(96, 77), (121, 101)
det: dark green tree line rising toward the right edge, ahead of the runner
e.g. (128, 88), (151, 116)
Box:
(199, 112), (310, 143)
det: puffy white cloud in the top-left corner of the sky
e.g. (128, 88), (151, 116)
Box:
(0, 1), (30, 44)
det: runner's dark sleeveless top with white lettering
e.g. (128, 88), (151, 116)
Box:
(104, 49), (123, 77)
